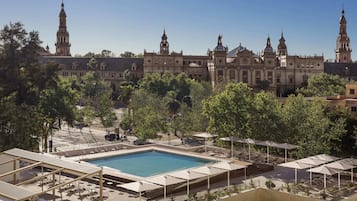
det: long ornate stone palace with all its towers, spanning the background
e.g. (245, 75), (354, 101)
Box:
(41, 3), (357, 96)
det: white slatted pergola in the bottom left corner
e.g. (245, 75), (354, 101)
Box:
(0, 148), (103, 200)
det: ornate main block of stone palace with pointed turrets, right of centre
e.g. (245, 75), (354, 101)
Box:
(204, 35), (324, 96)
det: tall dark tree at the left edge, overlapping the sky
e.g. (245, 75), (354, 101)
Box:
(0, 22), (74, 150)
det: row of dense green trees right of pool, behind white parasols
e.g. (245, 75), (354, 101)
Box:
(203, 83), (352, 156)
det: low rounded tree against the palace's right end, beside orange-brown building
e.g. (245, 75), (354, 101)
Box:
(297, 73), (348, 96)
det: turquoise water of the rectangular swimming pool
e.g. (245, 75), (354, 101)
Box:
(88, 151), (213, 177)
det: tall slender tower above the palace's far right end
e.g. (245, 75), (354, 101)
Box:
(336, 9), (352, 63)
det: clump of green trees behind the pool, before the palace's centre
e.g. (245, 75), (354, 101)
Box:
(121, 73), (211, 139)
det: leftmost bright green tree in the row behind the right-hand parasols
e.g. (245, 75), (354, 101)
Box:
(203, 83), (253, 137)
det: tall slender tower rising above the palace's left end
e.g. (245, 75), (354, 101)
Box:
(55, 1), (71, 56)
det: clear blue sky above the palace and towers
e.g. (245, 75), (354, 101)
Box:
(0, 0), (357, 60)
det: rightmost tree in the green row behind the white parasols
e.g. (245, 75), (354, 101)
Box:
(282, 95), (346, 156)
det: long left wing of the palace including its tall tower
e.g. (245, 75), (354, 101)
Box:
(40, 3), (144, 89)
